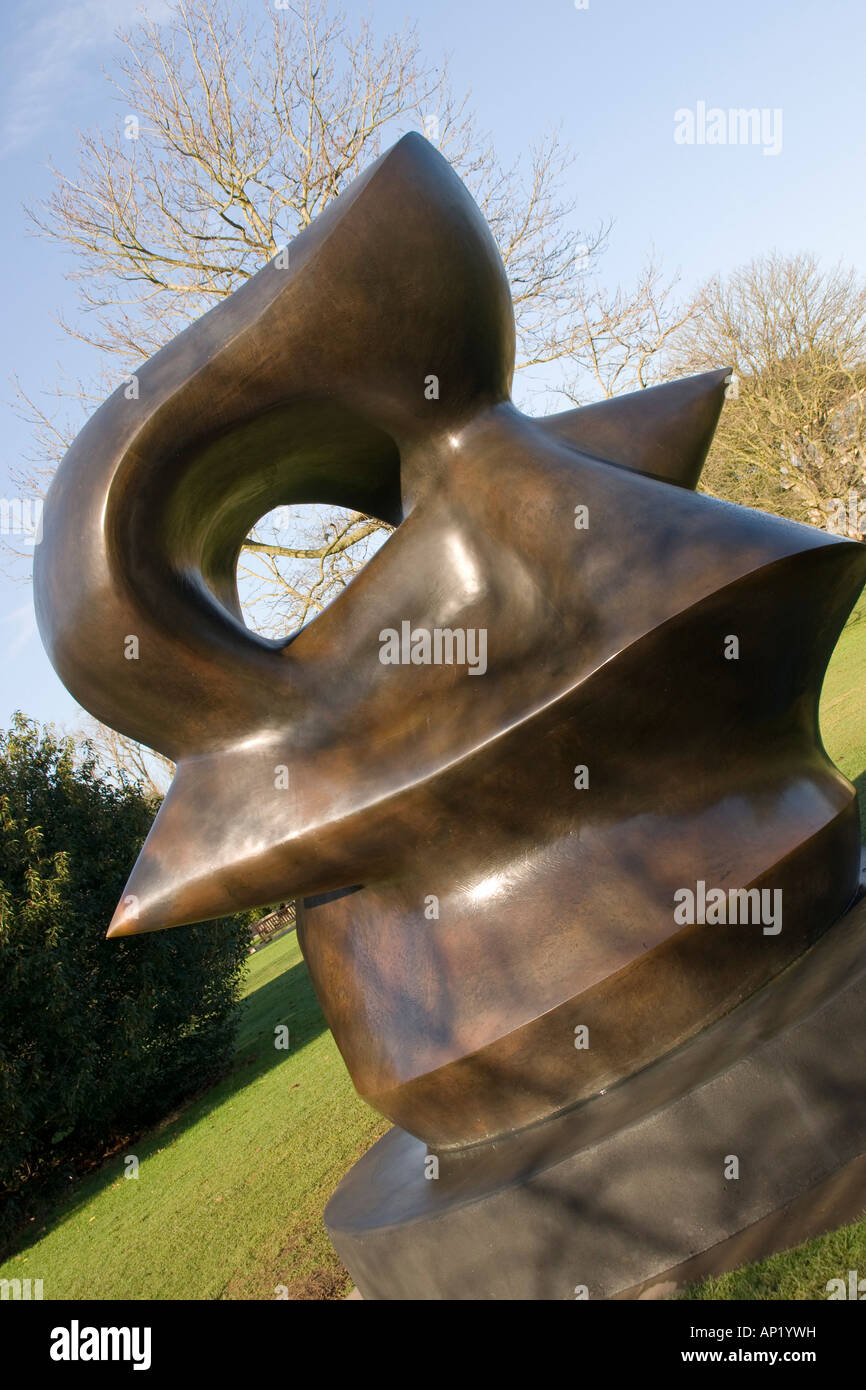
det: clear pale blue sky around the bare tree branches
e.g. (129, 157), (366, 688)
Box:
(0, 0), (866, 724)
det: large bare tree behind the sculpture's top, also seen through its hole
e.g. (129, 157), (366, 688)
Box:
(13, 0), (606, 631)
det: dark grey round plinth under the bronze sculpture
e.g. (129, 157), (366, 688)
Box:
(325, 899), (866, 1300)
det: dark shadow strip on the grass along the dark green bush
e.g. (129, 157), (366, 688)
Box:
(0, 942), (327, 1262)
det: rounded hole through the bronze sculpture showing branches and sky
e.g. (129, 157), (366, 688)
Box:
(238, 503), (392, 638)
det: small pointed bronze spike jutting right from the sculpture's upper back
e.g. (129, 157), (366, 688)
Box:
(538, 367), (731, 488)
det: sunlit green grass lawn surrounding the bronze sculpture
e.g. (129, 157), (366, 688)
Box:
(0, 599), (866, 1298)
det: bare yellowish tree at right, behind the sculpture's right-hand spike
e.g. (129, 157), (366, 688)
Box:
(677, 253), (866, 539)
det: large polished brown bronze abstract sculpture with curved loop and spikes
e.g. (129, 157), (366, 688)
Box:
(36, 135), (866, 1297)
